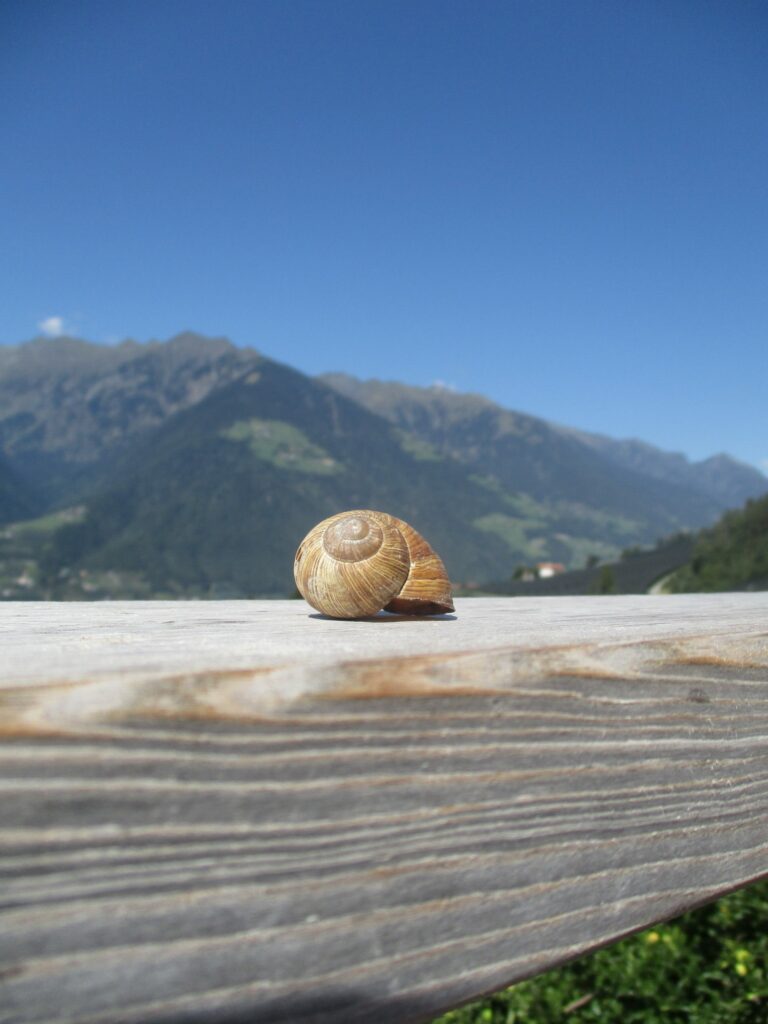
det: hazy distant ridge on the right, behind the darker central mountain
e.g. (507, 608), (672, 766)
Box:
(322, 374), (768, 540)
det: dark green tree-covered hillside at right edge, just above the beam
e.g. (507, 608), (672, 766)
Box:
(669, 496), (768, 593)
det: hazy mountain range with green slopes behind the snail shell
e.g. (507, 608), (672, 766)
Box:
(0, 333), (768, 596)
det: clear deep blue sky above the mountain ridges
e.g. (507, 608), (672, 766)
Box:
(0, 0), (768, 468)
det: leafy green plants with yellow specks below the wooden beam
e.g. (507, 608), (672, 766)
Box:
(434, 882), (768, 1024)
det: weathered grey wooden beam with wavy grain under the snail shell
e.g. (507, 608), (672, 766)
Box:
(0, 594), (768, 1024)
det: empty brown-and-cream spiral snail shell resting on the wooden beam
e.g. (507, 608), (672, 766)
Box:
(293, 509), (454, 618)
